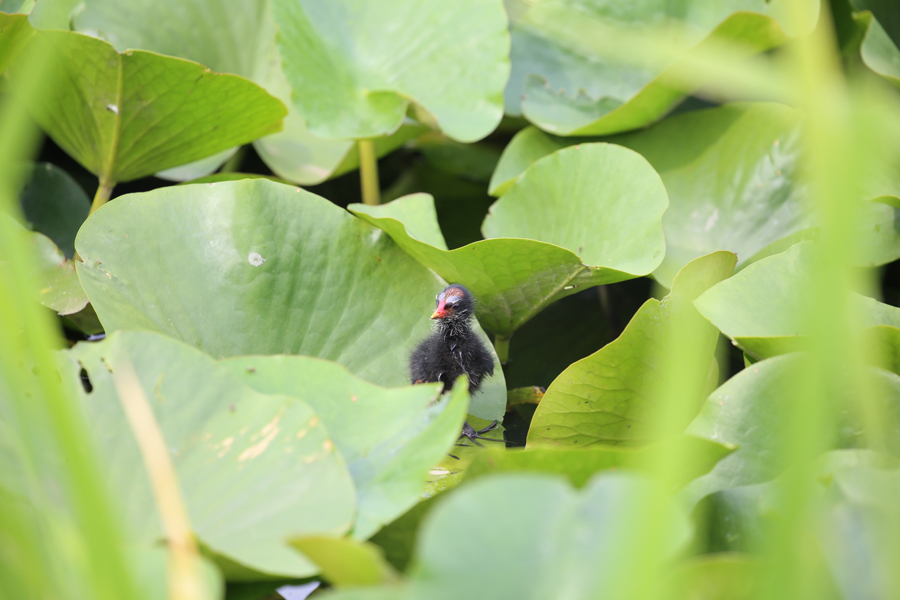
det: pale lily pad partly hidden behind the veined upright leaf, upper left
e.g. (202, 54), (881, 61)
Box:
(55, 0), (424, 185)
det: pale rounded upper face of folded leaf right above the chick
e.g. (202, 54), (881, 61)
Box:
(482, 144), (669, 280)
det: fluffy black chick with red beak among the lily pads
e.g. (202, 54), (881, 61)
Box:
(409, 284), (494, 394)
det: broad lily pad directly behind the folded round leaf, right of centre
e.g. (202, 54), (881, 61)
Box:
(490, 103), (900, 287)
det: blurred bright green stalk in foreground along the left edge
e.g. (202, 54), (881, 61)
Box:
(0, 34), (145, 600)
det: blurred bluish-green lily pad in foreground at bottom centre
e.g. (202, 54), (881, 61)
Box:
(323, 473), (689, 600)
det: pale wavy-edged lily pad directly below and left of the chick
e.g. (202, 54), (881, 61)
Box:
(220, 356), (468, 539)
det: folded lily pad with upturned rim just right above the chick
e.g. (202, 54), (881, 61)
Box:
(349, 144), (666, 336)
